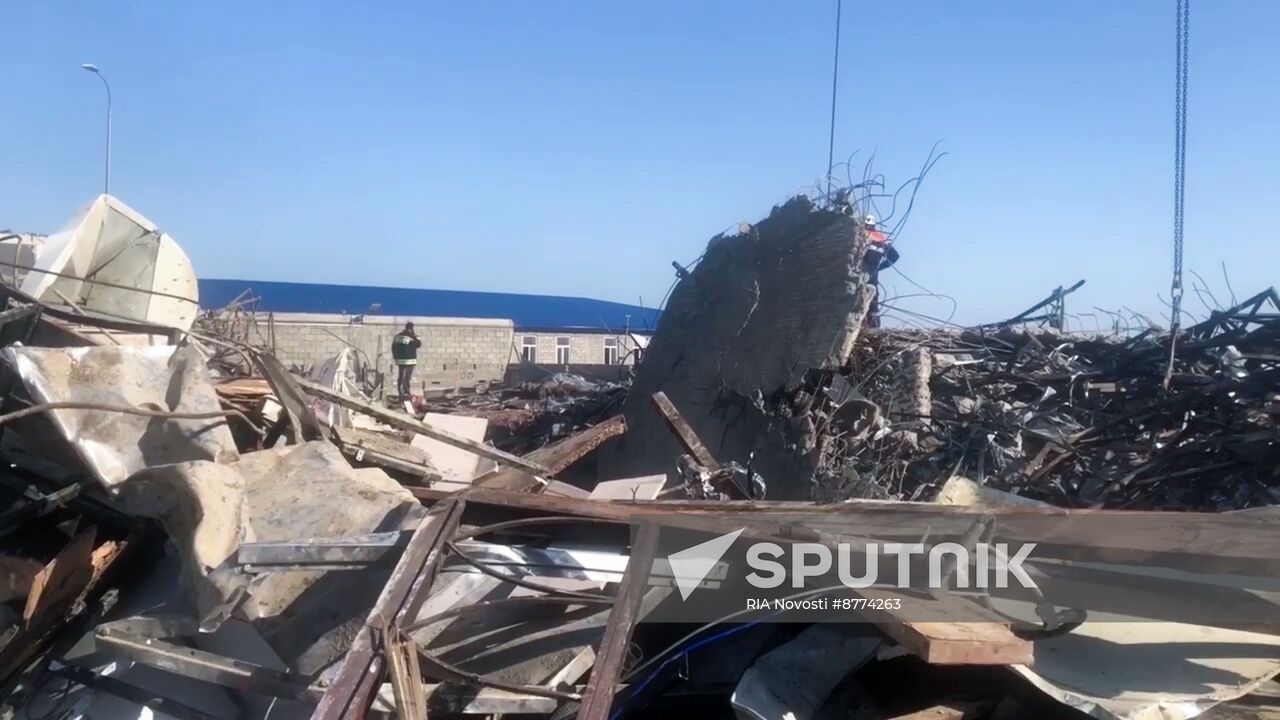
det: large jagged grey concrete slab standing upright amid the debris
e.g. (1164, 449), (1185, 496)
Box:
(600, 197), (872, 500)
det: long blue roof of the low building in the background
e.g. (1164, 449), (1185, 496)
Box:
(200, 278), (658, 332)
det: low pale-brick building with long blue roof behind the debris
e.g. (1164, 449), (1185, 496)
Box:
(198, 278), (658, 392)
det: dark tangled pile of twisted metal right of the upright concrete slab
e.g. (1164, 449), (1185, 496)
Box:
(829, 301), (1280, 510)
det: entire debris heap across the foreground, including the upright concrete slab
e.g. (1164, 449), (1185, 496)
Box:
(0, 192), (1280, 720)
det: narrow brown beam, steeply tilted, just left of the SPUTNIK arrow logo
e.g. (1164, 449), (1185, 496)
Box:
(577, 524), (658, 720)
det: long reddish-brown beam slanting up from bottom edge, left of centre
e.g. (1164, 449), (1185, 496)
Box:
(311, 501), (462, 720)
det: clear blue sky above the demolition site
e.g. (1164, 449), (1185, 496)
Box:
(0, 0), (1280, 323)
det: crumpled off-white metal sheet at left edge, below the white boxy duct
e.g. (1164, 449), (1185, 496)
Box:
(4, 346), (239, 489)
